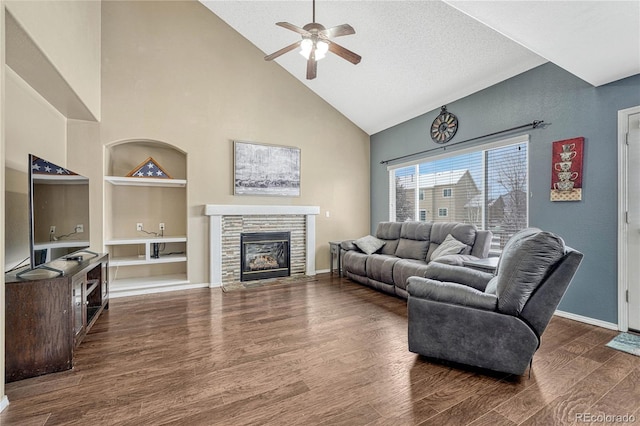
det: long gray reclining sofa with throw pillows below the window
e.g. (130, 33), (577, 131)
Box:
(341, 222), (492, 299)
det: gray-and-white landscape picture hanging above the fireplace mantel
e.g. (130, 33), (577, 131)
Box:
(233, 141), (300, 197)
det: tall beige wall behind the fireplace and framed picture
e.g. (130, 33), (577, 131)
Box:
(100, 1), (369, 283)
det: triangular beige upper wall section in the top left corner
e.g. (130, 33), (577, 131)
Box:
(6, 1), (101, 119)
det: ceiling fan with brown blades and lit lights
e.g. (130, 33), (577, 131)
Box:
(264, 0), (362, 80)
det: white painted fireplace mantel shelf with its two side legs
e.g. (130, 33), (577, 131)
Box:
(204, 204), (320, 287)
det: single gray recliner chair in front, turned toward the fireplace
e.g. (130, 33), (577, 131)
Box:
(407, 228), (583, 375)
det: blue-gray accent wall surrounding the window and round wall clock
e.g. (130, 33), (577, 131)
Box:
(371, 63), (640, 323)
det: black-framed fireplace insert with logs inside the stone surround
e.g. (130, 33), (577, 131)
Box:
(240, 232), (291, 281)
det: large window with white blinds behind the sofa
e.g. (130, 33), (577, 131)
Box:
(388, 135), (529, 250)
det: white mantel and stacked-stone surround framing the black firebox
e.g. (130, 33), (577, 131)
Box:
(204, 204), (320, 288)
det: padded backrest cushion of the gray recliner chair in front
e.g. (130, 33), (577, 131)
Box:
(496, 228), (565, 315)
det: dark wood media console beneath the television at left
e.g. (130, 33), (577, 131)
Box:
(5, 254), (109, 383)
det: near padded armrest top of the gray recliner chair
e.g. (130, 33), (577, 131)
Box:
(407, 277), (498, 311)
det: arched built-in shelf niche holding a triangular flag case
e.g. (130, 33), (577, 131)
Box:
(104, 140), (189, 297)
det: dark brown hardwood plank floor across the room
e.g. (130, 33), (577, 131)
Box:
(0, 274), (640, 426)
